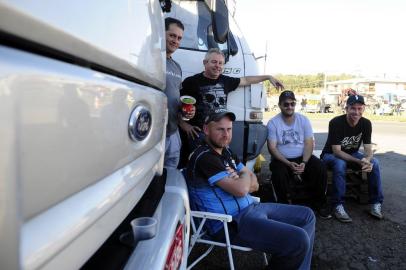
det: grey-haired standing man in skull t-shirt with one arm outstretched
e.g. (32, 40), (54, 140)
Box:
(181, 48), (283, 150)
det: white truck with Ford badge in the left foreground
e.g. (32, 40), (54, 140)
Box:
(0, 0), (189, 269)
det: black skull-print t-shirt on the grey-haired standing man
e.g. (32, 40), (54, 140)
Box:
(180, 72), (240, 128)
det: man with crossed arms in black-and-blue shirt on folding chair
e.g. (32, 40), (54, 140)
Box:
(186, 109), (315, 269)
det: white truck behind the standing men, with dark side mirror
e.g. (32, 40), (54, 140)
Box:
(167, 0), (267, 169)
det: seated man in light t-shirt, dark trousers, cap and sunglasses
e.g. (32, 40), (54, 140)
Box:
(267, 91), (331, 219)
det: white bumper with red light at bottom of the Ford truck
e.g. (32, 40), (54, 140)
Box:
(124, 169), (190, 270)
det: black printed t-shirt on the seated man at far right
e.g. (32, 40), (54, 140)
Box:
(322, 114), (372, 156)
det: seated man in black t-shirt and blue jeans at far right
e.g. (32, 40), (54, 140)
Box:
(321, 95), (383, 222)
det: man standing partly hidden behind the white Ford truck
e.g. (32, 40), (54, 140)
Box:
(164, 17), (195, 168)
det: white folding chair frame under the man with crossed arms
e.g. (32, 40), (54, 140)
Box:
(187, 197), (268, 270)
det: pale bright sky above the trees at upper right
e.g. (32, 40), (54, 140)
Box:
(235, 0), (406, 78)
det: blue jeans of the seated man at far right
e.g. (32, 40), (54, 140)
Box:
(323, 152), (383, 206)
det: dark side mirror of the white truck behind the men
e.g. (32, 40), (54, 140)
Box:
(211, 0), (229, 44)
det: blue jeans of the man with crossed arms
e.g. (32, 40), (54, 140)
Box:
(233, 203), (316, 270)
